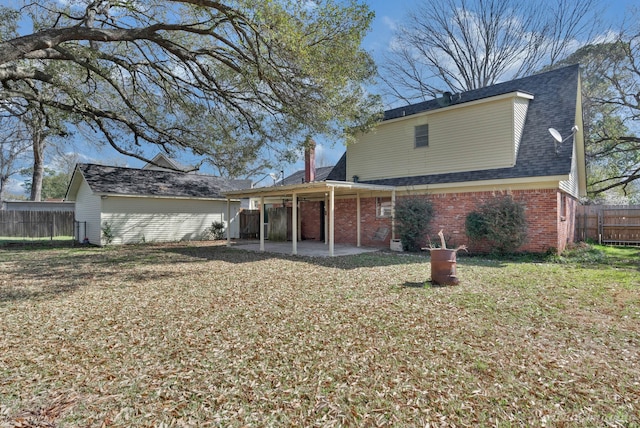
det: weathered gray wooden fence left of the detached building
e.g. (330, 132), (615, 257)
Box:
(0, 210), (74, 239)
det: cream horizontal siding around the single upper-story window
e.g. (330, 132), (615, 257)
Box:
(347, 95), (528, 180)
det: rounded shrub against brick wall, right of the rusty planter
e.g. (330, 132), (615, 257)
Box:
(465, 195), (527, 254)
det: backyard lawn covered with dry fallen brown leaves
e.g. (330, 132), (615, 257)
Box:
(0, 243), (640, 427)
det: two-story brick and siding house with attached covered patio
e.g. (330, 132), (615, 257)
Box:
(227, 65), (586, 253)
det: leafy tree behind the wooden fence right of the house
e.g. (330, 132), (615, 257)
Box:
(544, 36), (640, 201)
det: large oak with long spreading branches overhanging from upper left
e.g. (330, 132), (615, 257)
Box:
(0, 0), (380, 175)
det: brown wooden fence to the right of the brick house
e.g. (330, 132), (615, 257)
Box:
(576, 205), (640, 245)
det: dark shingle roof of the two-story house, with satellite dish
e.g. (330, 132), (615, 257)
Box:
(329, 65), (579, 186)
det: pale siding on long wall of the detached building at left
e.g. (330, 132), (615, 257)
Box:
(102, 196), (240, 244)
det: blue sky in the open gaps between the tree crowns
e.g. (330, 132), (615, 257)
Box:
(5, 0), (637, 193)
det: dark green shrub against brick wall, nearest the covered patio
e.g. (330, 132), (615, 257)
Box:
(395, 196), (433, 251)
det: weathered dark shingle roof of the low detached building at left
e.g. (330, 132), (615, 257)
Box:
(77, 164), (251, 198)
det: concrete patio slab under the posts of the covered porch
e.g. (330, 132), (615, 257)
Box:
(231, 240), (381, 257)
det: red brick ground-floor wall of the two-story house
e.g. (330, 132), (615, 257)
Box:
(301, 189), (578, 252)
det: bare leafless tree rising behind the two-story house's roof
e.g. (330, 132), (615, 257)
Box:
(382, 0), (598, 102)
